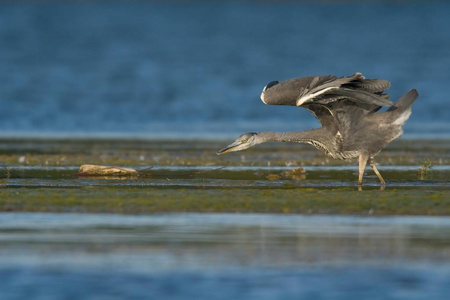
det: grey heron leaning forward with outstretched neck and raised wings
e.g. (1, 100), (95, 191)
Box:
(217, 73), (418, 185)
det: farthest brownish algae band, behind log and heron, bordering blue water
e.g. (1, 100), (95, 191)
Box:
(0, 139), (450, 167)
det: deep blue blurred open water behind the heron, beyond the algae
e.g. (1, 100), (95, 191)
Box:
(0, 1), (450, 136)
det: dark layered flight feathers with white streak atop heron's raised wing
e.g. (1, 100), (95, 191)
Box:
(296, 73), (393, 106)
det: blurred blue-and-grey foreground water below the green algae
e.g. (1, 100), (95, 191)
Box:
(0, 213), (450, 299)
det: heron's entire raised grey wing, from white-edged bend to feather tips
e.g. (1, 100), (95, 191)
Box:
(261, 73), (393, 132)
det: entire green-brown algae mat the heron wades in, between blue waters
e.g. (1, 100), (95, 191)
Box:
(0, 139), (450, 215)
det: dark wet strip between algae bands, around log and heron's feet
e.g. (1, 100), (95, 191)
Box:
(0, 165), (450, 188)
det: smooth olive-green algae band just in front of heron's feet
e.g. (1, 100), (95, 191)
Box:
(0, 185), (450, 215)
